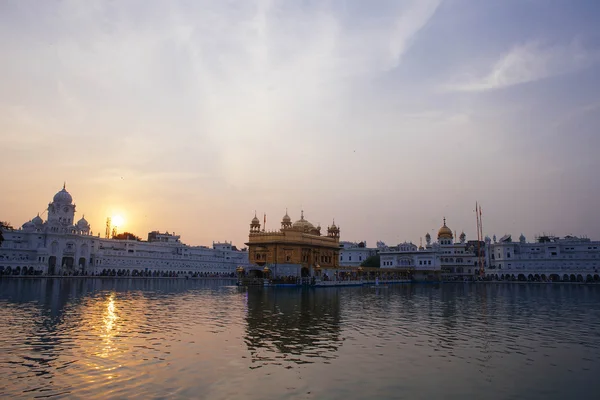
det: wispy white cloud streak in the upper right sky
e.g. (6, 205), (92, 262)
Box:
(445, 40), (600, 92)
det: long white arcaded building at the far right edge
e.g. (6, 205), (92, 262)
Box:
(485, 235), (600, 281)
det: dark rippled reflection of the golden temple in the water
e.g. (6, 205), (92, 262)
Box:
(240, 287), (342, 364)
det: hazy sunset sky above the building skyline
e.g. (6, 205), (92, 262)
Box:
(0, 0), (600, 247)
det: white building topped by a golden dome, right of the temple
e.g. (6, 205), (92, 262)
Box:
(380, 218), (483, 279)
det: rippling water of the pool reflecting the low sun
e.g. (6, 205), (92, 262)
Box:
(0, 279), (600, 400)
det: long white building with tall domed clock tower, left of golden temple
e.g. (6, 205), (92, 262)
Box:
(0, 186), (248, 276)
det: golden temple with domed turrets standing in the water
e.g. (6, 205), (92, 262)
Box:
(246, 212), (340, 277)
